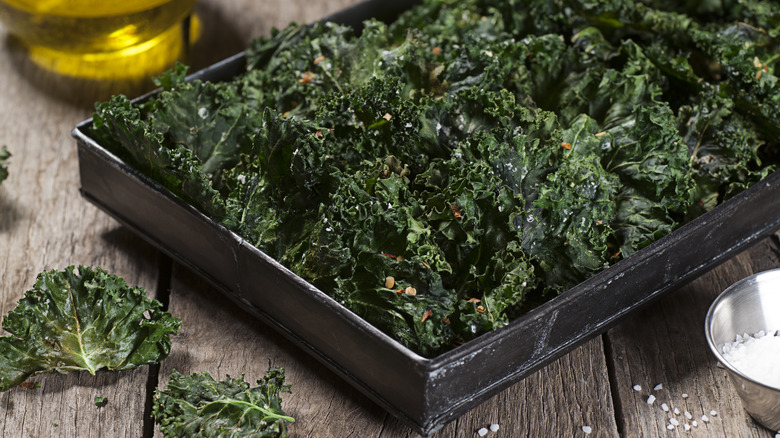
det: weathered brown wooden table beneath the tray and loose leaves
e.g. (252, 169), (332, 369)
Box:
(0, 0), (780, 438)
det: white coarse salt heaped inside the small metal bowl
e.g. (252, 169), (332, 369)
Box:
(721, 330), (780, 388)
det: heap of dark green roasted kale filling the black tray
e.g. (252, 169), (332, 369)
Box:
(92, 0), (780, 356)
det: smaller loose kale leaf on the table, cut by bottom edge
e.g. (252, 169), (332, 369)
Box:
(152, 367), (295, 438)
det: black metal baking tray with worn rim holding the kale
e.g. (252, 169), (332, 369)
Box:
(73, 0), (780, 435)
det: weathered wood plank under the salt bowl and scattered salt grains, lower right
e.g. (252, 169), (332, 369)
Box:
(606, 238), (780, 437)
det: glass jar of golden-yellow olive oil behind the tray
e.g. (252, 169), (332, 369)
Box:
(0, 0), (196, 79)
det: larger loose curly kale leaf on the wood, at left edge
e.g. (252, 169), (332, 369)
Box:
(0, 266), (181, 391)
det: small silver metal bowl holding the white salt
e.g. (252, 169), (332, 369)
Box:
(704, 269), (780, 431)
